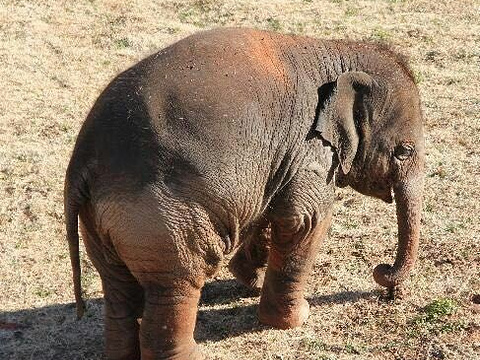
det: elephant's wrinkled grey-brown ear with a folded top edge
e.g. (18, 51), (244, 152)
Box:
(315, 71), (375, 174)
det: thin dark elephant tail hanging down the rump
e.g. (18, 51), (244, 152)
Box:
(64, 167), (88, 319)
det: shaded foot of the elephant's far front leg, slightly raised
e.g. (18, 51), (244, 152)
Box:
(228, 252), (266, 296)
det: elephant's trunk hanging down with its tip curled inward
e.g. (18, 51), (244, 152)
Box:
(373, 176), (423, 289)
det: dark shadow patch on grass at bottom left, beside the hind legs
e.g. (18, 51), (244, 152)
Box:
(0, 299), (104, 360)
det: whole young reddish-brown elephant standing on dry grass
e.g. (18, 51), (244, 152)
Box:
(64, 28), (425, 360)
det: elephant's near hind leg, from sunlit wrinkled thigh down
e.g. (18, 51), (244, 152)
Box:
(96, 191), (224, 360)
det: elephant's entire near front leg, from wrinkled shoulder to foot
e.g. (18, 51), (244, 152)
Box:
(258, 167), (334, 329)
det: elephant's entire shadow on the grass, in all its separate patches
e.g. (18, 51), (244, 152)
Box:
(0, 280), (377, 360)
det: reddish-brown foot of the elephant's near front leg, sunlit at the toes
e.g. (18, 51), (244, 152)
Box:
(258, 294), (310, 330)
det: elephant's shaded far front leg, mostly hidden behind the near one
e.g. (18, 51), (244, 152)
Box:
(228, 222), (270, 294)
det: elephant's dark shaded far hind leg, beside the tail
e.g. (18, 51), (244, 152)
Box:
(80, 207), (144, 360)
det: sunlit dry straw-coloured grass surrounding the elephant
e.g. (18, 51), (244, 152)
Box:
(0, 0), (480, 359)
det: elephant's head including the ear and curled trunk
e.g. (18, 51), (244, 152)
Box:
(316, 71), (425, 289)
